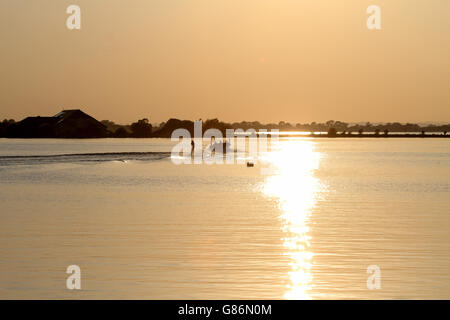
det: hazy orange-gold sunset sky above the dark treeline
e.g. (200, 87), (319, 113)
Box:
(0, 0), (450, 123)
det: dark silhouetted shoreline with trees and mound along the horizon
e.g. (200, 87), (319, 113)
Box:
(0, 109), (450, 138)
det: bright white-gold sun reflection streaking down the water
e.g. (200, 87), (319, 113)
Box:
(263, 140), (321, 299)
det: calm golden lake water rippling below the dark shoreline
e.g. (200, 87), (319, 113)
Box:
(0, 138), (450, 299)
